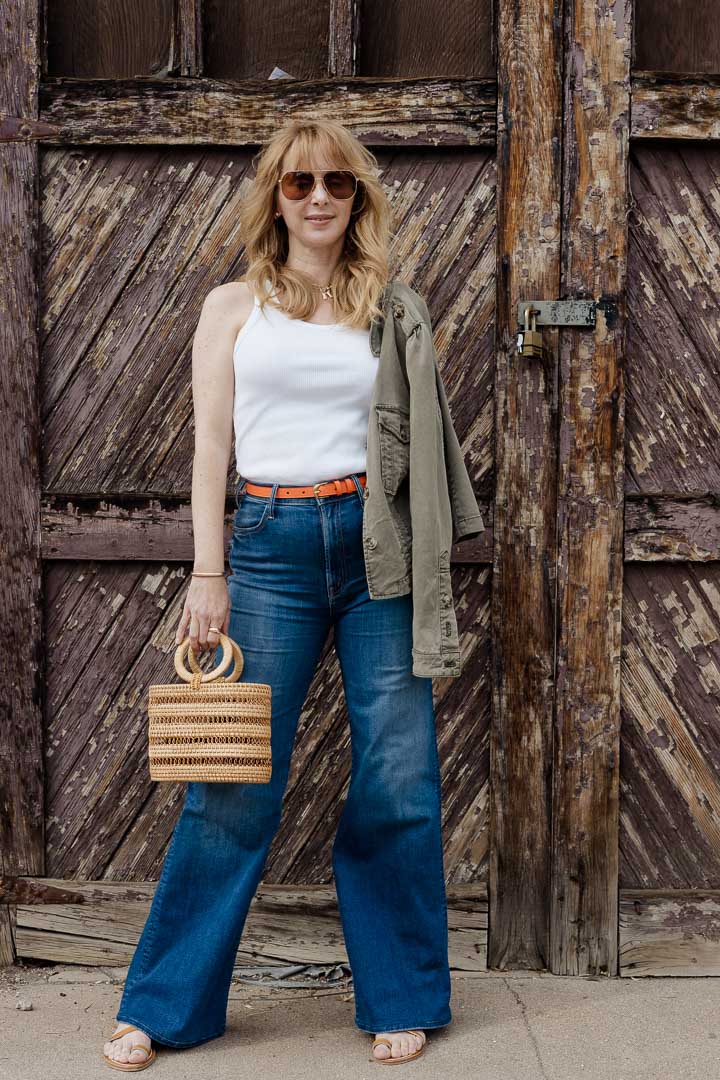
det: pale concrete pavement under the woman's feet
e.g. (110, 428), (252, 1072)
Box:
(0, 963), (720, 1080)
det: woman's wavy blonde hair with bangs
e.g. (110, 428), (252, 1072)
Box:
(240, 119), (392, 328)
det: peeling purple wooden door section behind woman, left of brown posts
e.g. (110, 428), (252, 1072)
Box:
(0, 0), (495, 971)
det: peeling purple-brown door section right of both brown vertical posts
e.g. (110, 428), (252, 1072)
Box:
(619, 14), (720, 976)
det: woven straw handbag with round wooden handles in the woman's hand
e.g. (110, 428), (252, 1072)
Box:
(148, 634), (272, 784)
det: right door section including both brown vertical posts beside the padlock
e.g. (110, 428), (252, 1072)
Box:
(488, 0), (720, 975)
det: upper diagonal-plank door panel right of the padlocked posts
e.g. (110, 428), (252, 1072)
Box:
(625, 144), (720, 498)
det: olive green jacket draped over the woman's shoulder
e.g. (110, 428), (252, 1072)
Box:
(363, 279), (485, 676)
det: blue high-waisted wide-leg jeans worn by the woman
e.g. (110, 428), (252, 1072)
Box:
(118, 474), (451, 1047)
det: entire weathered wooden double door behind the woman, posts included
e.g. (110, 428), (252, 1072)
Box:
(0, 0), (720, 975)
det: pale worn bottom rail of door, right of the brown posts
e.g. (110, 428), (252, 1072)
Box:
(620, 889), (720, 978)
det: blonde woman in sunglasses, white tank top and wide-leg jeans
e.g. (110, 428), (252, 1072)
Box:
(105, 120), (451, 1069)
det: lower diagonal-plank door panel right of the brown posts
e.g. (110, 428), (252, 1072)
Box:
(620, 562), (720, 889)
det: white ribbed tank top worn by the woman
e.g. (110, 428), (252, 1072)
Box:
(233, 285), (378, 485)
